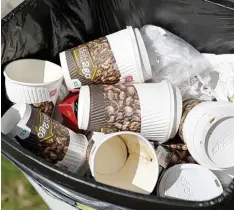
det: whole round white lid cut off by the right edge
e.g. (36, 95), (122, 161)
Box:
(183, 102), (234, 170)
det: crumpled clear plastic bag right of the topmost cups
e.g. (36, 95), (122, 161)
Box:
(140, 25), (212, 87)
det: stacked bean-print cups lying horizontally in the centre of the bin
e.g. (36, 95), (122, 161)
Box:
(78, 81), (182, 142)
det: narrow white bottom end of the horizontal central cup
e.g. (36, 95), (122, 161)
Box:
(77, 85), (90, 130)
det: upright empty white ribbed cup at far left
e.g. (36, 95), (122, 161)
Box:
(4, 59), (63, 116)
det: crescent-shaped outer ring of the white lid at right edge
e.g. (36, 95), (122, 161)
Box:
(183, 102), (234, 170)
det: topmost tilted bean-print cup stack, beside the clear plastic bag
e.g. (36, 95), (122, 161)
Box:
(60, 26), (152, 92)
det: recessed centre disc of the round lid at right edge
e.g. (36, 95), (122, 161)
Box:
(206, 117), (234, 168)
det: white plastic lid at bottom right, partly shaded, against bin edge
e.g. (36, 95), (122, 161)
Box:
(159, 164), (223, 201)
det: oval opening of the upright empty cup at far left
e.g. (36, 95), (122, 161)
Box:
(4, 59), (63, 85)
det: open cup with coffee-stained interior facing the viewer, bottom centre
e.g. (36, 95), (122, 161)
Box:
(88, 132), (159, 194)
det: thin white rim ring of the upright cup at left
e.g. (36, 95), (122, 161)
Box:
(3, 59), (63, 87)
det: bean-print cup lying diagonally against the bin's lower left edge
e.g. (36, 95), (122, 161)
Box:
(2, 104), (88, 173)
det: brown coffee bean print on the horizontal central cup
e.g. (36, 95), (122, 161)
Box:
(103, 84), (141, 132)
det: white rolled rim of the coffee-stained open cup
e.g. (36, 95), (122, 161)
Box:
(89, 131), (159, 190)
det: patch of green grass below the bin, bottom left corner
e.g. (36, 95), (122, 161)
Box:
(1, 156), (49, 210)
